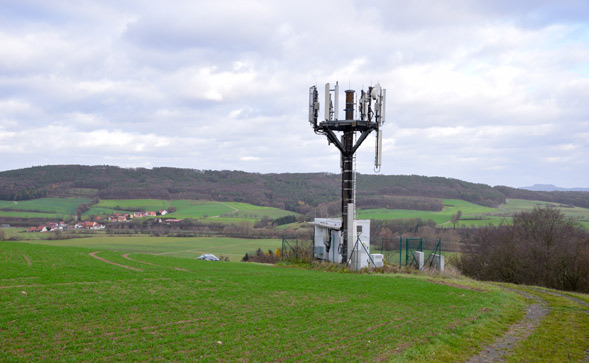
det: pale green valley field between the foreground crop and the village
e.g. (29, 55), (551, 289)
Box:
(12, 233), (282, 262)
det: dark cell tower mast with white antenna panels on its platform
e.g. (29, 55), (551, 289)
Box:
(309, 82), (386, 263)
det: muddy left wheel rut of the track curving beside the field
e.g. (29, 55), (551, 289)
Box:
(467, 288), (550, 363)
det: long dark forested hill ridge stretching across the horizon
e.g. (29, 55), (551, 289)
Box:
(0, 165), (589, 210)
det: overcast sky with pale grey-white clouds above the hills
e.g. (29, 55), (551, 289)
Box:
(0, 0), (589, 187)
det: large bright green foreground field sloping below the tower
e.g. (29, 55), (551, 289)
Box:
(0, 242), (523, 362)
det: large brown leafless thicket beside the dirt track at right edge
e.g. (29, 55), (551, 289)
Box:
(458, 208), (589, 292)
